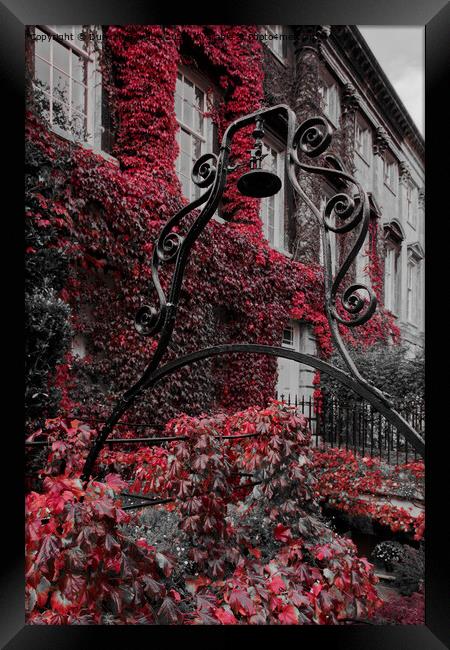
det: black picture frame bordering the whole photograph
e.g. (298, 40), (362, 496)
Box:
(0, 0), (450, 650)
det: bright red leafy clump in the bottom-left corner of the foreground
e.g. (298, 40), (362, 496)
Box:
(26, 474), (181, 625)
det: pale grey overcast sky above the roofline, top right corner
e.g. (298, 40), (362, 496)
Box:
(358, 25), (425, 135)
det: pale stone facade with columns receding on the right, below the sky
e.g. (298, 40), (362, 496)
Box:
(261, 25), (425, 395)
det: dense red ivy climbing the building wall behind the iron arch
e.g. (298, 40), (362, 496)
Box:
(27, 25), (395, 422)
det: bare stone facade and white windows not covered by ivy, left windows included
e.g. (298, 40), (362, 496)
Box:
(28, 25), (425, 410)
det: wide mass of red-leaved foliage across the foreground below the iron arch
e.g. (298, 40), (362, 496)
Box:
(27, 402), (380, 624)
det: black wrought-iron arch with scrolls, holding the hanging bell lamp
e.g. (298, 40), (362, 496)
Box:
(82, 104), (425, 481)
